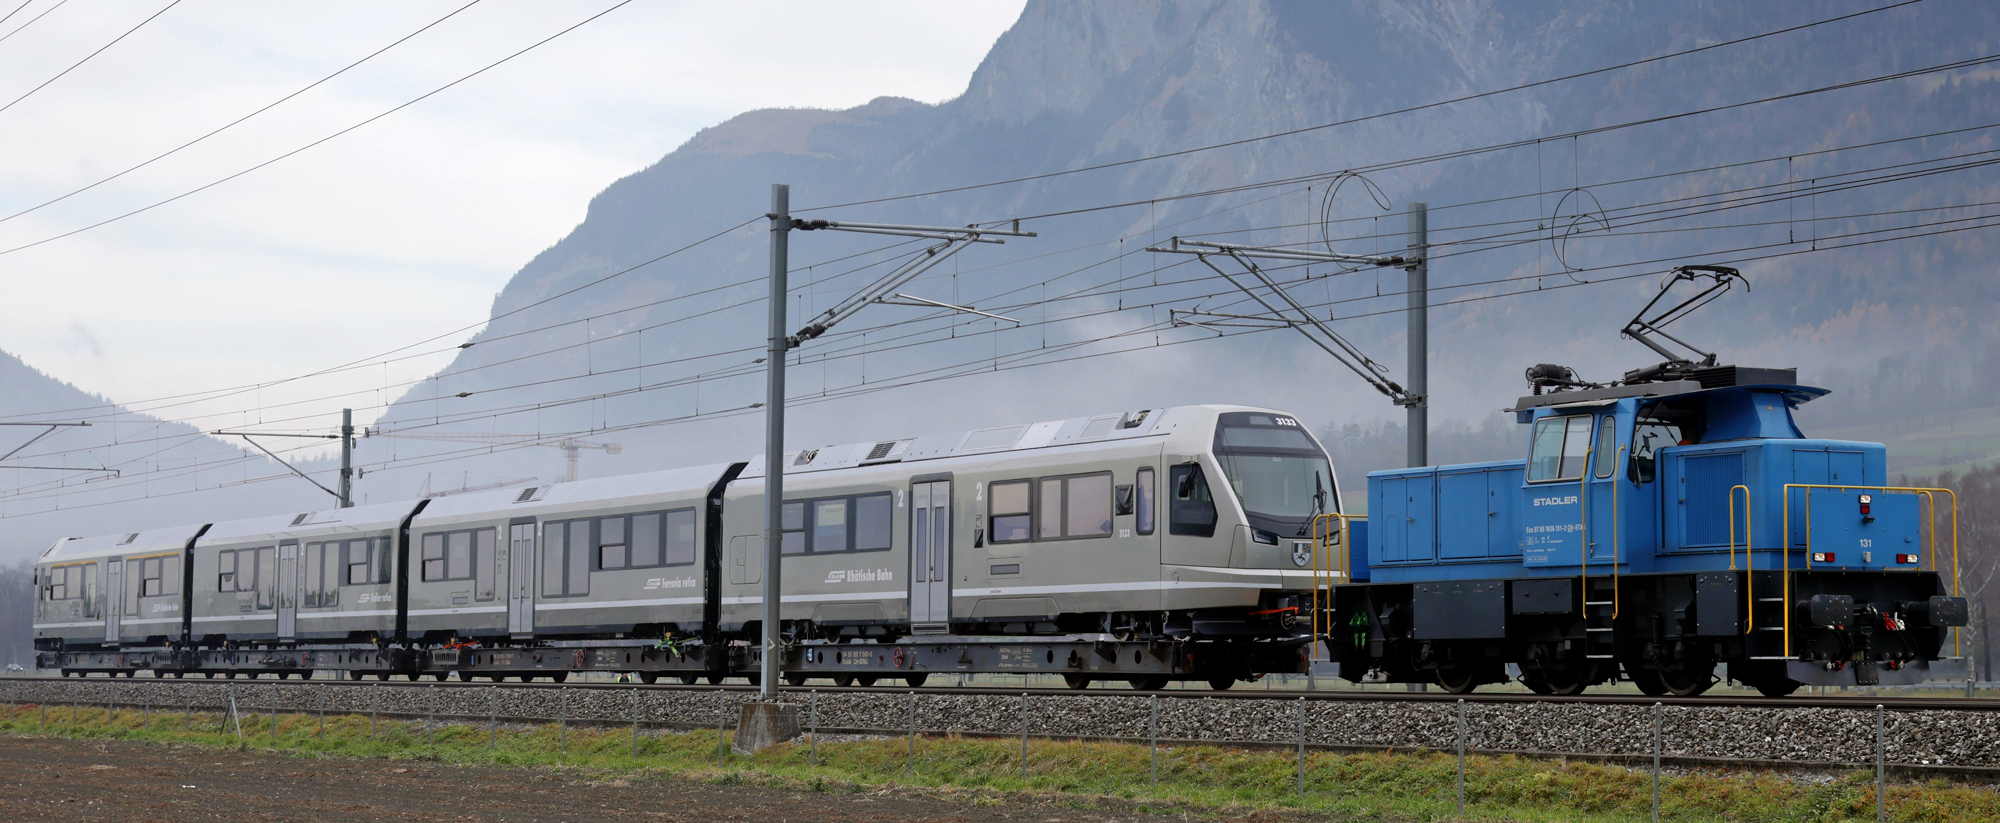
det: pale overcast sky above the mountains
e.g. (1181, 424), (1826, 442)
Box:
(0, 0), (1022, 427)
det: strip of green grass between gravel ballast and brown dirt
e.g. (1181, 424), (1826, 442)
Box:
(0, 705), (2000, 823)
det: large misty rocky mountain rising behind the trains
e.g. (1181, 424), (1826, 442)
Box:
(344, 0), (2000, 497)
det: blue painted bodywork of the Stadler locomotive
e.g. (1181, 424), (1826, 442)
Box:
(1352, 386), (1928, 583)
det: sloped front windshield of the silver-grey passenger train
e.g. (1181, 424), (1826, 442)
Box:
(1216, 412), (1340, 535)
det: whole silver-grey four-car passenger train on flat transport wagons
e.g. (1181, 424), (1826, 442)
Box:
(34, 406), (1340, 687)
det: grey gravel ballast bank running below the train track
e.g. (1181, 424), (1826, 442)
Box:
(0, 677), (2000, 777)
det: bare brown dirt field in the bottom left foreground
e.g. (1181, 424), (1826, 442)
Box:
(0, 737), (1216, 823)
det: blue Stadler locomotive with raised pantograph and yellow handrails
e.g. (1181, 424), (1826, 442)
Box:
(1322, 266), (1966, 697)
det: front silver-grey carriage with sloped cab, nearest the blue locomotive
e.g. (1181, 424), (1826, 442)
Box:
(722, 406), (1338, 639)
